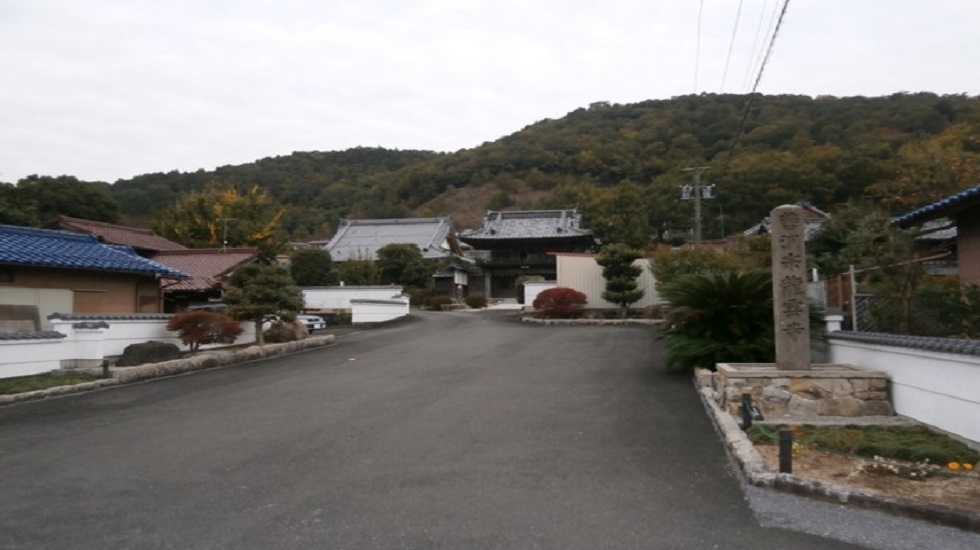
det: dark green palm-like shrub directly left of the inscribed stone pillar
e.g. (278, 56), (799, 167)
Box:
(660, 271), (776, 372)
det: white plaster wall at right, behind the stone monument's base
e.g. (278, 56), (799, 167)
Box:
(830, 339), (980, 442)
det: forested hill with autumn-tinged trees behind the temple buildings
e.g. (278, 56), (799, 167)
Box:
(111, 93), (980, 242)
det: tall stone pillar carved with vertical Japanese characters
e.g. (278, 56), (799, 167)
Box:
(769, 205), (810, 370)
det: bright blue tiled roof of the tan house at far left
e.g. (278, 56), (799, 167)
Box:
(0, 225), (187, 279)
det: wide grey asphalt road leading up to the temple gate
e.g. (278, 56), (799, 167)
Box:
(0, 312), (976, 550)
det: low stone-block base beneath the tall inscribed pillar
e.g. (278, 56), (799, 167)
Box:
(712, 363), (895, 421)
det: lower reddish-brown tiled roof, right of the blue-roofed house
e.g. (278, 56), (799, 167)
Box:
(153, 248), (259, 291)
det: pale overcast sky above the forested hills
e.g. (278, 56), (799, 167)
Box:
(0, 0), (980, 183)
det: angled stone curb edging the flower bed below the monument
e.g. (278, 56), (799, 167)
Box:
(695, 377), (980, 533)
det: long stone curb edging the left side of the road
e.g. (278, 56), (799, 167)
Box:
(0, 334), (336, 406)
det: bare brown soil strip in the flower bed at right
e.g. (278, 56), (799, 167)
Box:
(756, 445), (980, 513)
